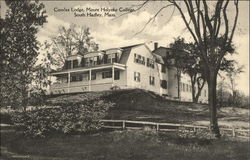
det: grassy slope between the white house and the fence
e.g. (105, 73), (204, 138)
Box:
(48, 89), (249, 128)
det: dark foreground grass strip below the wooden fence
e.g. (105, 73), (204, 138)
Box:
(1, 131), (250, 160)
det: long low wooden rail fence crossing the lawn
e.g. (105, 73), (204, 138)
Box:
(101, 120), (250, 138)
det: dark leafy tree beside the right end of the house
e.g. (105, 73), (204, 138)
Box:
(167, 37), (206, 102)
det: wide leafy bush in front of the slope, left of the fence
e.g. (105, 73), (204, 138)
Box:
(12, 100), (113, 137)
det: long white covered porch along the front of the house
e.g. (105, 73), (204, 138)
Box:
(50, 63), (126, 94)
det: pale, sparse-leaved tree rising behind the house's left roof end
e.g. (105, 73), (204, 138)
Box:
(44, 24), (98, 68)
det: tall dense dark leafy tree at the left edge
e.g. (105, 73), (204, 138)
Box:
(1, 0), (47, 109)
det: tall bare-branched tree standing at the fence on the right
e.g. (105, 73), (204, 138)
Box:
(122, 0), (239, 138)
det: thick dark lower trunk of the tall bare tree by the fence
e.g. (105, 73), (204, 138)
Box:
(208, 69), (221, 138)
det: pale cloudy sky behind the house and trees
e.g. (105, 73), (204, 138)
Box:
(0, 1), (249, 95)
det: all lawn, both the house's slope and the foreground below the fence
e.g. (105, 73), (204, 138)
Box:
(0, 90), (250, 160)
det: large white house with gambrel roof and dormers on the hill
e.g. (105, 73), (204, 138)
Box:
(50, 44), (207, 103)
